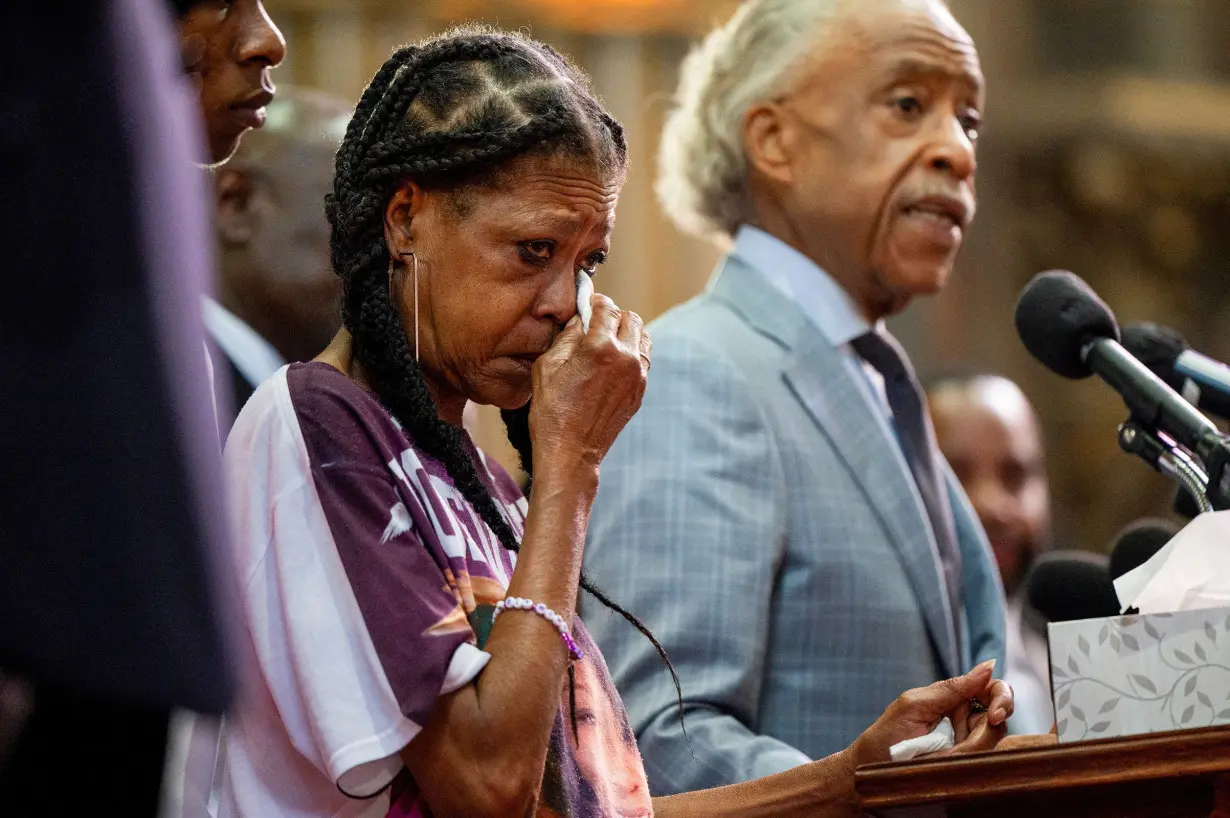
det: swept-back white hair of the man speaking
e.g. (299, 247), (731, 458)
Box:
(657, 0), (844, 236)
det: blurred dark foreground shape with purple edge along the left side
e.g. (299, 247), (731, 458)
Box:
(0, 0), (231, 818)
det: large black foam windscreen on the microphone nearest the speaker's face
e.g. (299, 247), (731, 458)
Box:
(1015, 269), (1119, 378)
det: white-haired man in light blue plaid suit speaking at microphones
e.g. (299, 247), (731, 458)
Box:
(585, 0), (1004, 795)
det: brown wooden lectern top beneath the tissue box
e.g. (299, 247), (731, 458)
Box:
(855, 727), (1230, 818)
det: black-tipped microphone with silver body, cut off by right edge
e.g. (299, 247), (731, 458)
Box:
(1123, 322), (1230, 419)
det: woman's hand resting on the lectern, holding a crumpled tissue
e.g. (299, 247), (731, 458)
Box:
(849, 662), (1014, 766)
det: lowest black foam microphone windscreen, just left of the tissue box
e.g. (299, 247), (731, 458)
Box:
(1025, 551), (1119, 622)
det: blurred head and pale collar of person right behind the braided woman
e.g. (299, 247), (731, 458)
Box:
(204, 87), (352, 412)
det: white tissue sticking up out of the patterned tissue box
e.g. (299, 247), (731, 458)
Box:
(1114, 510), (1230, 614)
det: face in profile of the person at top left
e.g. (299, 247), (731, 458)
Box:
(180, 0), (287, 164)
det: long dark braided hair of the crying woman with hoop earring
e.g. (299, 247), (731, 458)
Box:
(325, 26), (683, 733)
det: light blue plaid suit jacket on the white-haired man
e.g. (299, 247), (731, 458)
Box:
(582, 257), (1005, 795)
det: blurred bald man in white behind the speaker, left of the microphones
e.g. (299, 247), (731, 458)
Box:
(927, 375), (1054, 733)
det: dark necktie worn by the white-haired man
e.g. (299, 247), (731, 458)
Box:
(852, 332), (961, 638)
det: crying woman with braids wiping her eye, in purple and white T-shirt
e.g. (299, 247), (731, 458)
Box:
(214, 28), (1011, 818)
